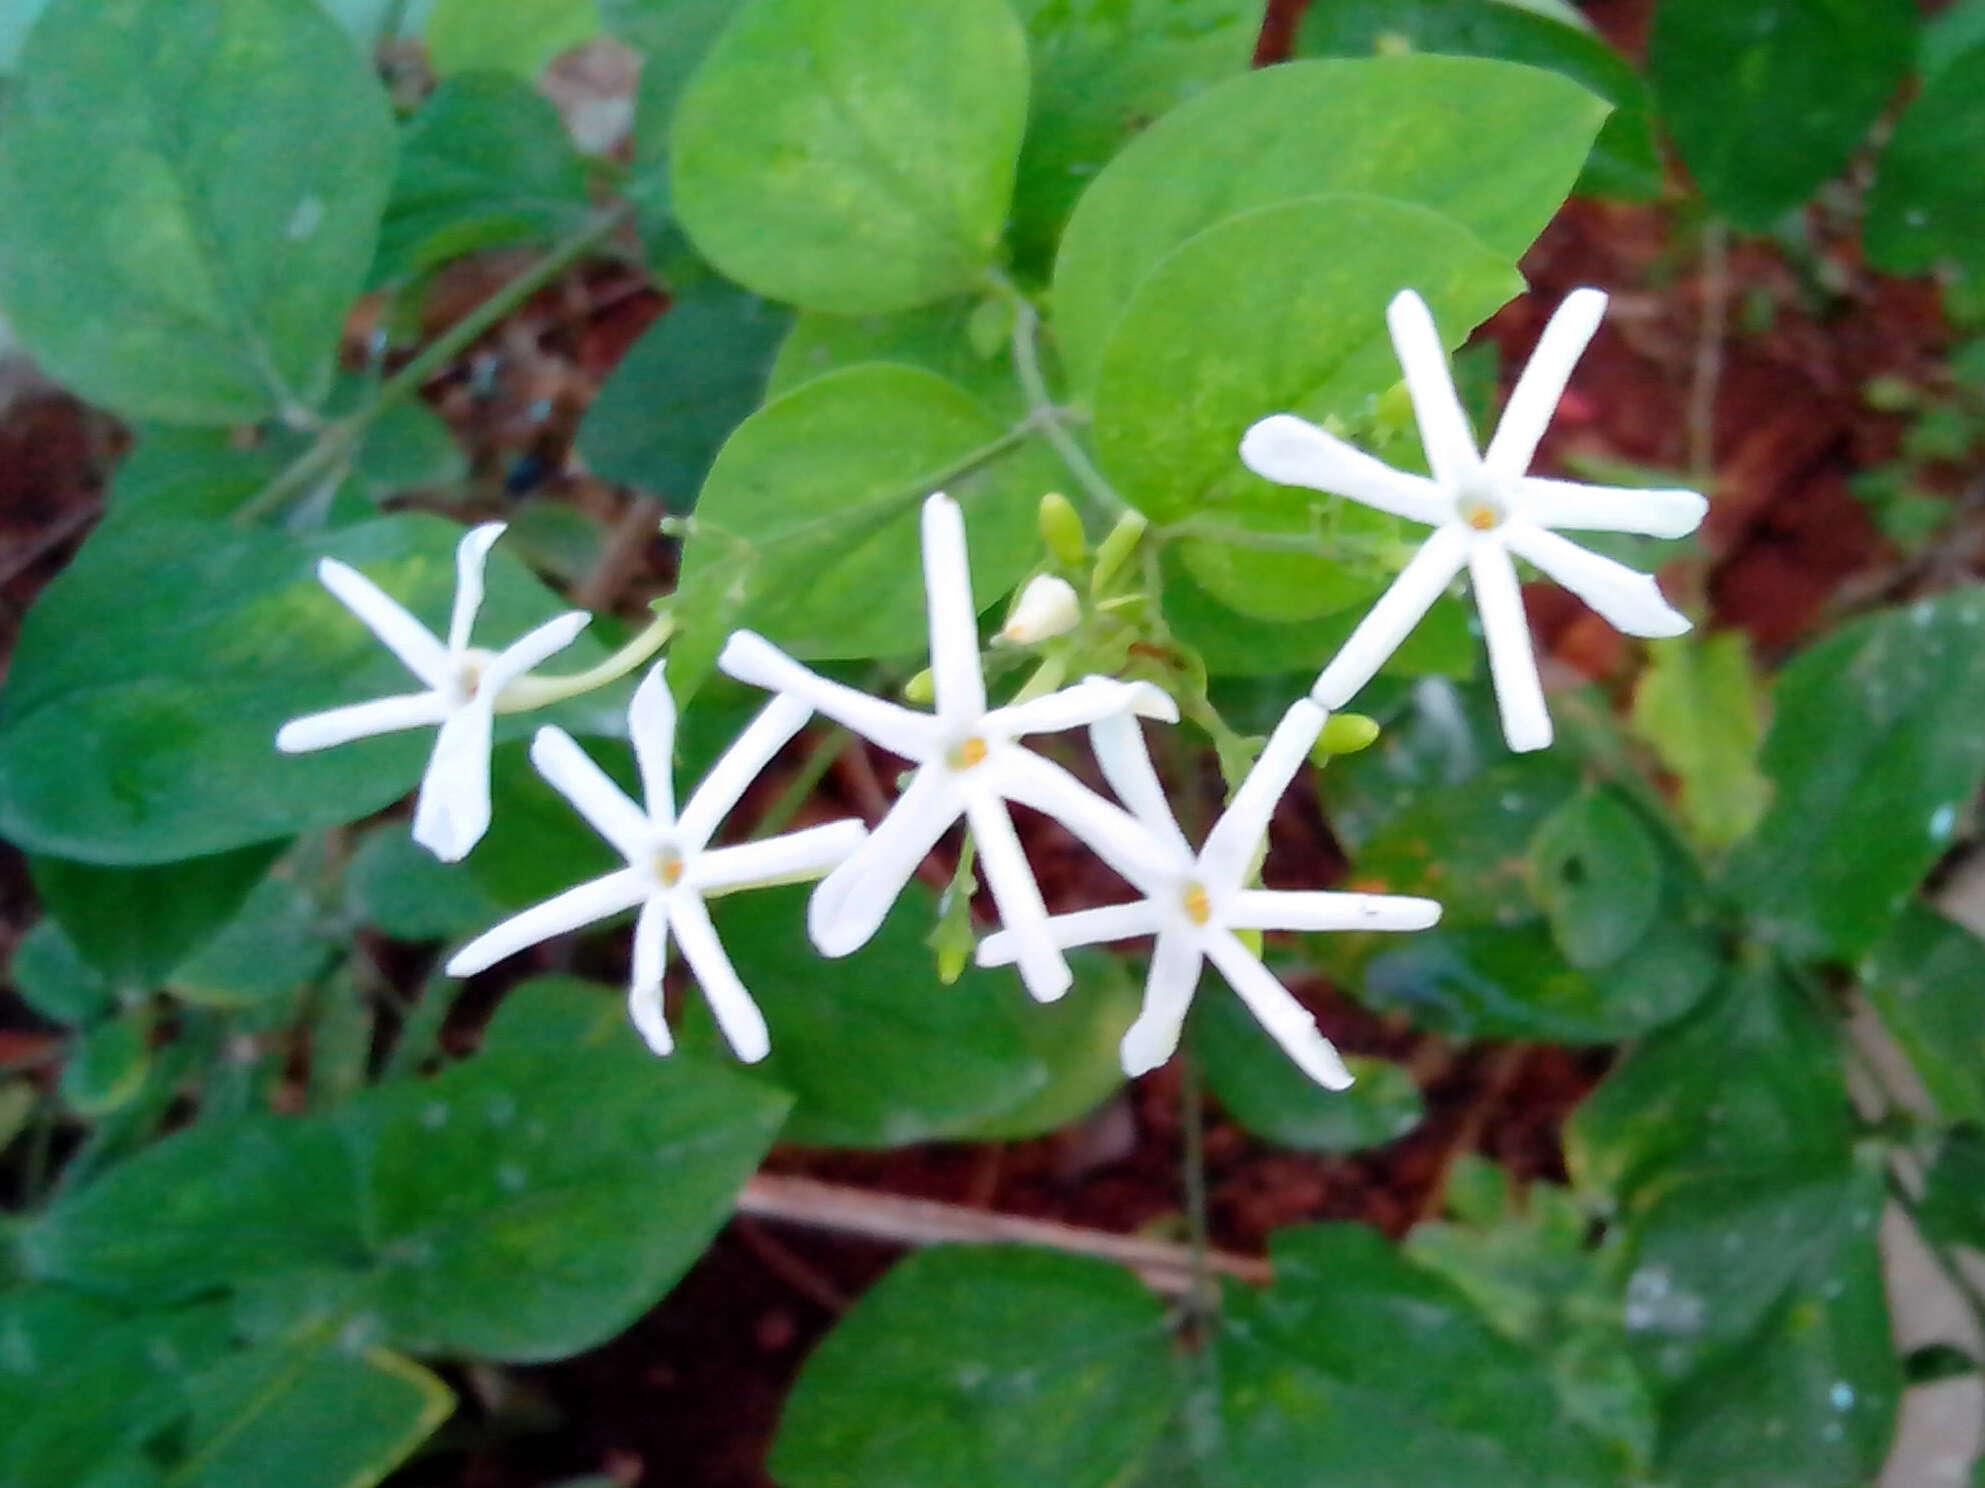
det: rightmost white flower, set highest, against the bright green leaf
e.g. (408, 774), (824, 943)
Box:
(1241, 290), (1709, 750)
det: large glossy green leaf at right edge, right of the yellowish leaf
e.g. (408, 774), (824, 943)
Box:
(1723, 589), (1985, 958)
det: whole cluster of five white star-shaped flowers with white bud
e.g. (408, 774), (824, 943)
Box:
(276, 290), (1705, 1089)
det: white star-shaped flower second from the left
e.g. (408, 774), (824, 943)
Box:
(449, 665), (863, 1061)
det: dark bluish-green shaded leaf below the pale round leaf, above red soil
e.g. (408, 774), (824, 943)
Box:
(578, 278), (790, 512)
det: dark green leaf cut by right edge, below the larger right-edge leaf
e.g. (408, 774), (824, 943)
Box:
(1860, 903), (1985, 1121)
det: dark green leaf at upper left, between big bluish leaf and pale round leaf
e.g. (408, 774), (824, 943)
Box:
(371, 69), (592, 284)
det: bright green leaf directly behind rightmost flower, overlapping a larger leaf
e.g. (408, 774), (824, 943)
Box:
(1096, 194), (1522, 523)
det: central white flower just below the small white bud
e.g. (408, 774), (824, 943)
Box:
(717, 494), (1177, 1002)
